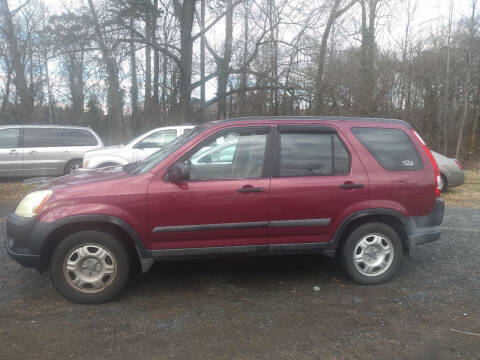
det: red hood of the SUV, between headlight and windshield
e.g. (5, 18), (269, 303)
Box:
(38, 166), (128, 190)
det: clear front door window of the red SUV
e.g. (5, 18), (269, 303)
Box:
(185, 129), (268, 180)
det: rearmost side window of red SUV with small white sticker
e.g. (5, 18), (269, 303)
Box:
(352, 128), (423, 171)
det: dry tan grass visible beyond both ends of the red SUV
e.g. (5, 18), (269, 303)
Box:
(0, 170), (480, 208)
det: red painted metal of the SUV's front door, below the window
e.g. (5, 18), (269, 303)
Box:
(148, 176), (270, 250)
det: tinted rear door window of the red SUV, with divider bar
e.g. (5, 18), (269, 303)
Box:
(280, 131), (350, 176)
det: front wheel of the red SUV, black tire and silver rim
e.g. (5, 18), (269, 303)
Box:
(50, 230), (130, 304)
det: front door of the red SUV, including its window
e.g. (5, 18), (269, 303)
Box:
(148, 127), (270, 253)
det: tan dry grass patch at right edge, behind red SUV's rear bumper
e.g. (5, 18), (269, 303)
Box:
(442, 170), (480, 208)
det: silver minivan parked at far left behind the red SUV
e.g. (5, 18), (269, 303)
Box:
(0, 125), (103, 177)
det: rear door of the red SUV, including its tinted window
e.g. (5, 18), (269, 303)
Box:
(269, 126), (369, 250)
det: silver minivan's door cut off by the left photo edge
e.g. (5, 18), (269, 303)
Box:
(0, 127), (23, 177)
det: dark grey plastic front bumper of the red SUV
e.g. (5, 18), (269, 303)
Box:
(5, 214), (46, 268)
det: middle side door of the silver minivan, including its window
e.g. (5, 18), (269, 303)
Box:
(23, 126), (64, 176)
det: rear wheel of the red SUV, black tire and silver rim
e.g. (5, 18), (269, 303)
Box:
(341, 222), (403, 285)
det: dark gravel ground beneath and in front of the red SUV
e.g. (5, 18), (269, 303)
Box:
(0, 208), (480, 360)
